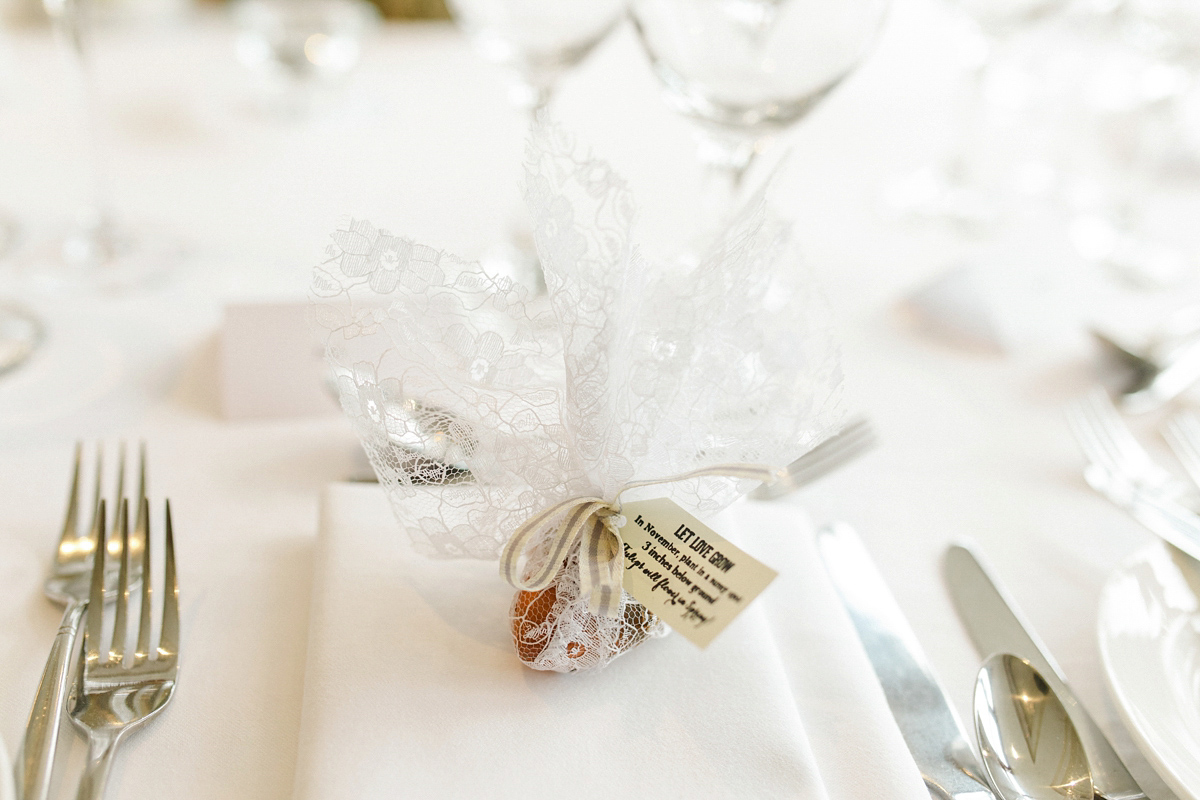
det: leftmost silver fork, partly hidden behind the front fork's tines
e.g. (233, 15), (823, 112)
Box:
(16, 444), (146, 800)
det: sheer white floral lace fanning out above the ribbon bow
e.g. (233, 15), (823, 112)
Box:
(312, 126), (841, 671)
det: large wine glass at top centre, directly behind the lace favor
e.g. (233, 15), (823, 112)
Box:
(630, 0), (888, 241)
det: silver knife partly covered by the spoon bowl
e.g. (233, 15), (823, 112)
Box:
(944, 545), (1146, 800)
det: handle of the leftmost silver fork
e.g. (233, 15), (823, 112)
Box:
(17, 601), (88, 800)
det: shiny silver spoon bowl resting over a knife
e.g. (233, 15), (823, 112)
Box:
(974, 654), (1094, 800)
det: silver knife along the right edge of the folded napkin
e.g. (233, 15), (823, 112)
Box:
(817, 523), (996, 800)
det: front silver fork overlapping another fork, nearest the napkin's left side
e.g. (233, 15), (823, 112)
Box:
(71, 498), (179, 800)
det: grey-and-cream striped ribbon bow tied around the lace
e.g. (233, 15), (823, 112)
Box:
(500, 464), (786, 618)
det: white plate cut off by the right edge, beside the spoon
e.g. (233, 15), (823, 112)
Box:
(1098, 543), (1200, 800)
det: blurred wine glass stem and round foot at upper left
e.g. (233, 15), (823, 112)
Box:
(35, 0), (186, 290)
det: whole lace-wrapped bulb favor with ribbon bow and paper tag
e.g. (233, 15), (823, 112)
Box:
(313, 126), (840, 672)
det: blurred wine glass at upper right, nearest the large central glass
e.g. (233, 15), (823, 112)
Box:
(888, 0), (1066, 233)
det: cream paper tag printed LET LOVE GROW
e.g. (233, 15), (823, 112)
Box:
(620, 498), (779, 648)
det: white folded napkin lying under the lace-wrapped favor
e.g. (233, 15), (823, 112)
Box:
(295, 485), (928, 800)
